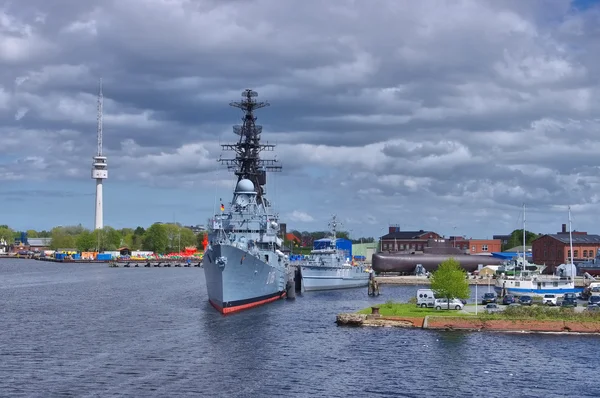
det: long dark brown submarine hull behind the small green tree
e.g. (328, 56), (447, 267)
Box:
(373, 253), (503, 272)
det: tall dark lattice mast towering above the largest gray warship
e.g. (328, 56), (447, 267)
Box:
(218, 89), (281, 207)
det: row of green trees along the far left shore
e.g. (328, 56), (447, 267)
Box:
(0, 223), (205, 254)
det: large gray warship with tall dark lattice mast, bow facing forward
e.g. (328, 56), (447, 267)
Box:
(203, 89), (290, 314)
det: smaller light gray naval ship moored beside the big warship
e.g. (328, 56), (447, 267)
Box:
(298, 215), (369, 292)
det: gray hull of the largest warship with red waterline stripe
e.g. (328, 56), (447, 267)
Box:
(204, 245), (287, 314)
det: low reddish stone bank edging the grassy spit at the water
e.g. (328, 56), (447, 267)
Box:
(336, 313), (600, 334)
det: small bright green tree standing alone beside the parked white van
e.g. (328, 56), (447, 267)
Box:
(431, 257), (471, 309)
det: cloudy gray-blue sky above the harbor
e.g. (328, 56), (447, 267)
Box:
(0, 0), (600, 238)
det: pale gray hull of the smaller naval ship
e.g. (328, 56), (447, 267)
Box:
(299, 266), (369, 292)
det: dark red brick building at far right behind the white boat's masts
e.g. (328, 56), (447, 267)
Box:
(531, 224), (600, 271)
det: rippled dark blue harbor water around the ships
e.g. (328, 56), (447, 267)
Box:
(0, 259), (600, 398)
